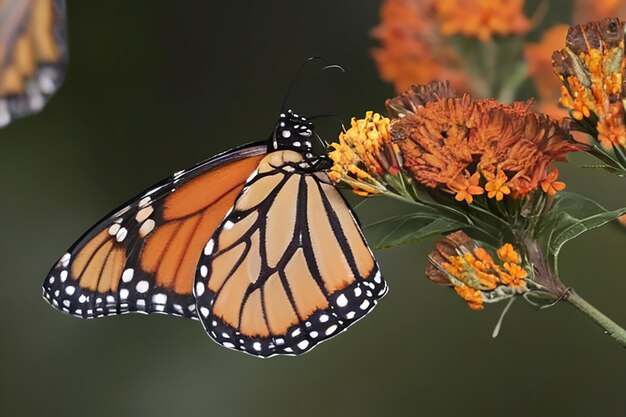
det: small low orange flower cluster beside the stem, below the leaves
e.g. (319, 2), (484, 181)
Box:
(426, 231), (528, 310)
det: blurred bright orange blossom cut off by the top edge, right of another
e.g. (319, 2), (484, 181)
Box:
(435, 0), (531, 41)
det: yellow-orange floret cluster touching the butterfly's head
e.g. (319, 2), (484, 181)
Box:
(328, 111), (400, 197)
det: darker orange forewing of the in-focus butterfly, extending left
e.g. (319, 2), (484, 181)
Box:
(43, 143), (267, 318)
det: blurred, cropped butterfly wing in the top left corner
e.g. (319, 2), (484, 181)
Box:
(0, 0), (67, 126)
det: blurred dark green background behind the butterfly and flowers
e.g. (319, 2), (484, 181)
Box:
(0, 0), (626, 417)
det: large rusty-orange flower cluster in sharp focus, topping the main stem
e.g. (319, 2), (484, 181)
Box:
(387, 83), (580, 203)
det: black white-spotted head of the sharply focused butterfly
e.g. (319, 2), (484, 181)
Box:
(269, 110), (313, 155)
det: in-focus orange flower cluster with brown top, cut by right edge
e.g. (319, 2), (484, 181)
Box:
(552, 18), (626, 149)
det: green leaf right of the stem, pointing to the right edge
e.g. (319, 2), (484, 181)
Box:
(535, 192), (626, 273)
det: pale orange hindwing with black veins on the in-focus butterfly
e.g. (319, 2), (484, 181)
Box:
(194, 150), (387, 357)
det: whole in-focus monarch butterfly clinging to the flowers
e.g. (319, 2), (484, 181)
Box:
(43, 107), (387, 357)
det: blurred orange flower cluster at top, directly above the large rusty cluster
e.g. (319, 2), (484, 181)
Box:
(372, 0), (466, 91)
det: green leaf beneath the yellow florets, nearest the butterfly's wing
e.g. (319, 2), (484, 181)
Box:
(366, 213), (467, 249)
